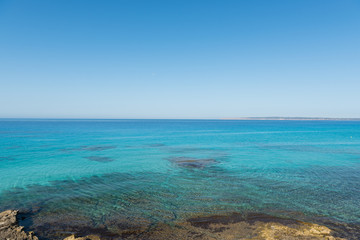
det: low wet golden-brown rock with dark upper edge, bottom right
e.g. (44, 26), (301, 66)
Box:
(187, 213), (343, 240)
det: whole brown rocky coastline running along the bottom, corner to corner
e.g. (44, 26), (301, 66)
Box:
(0, 210), (360, 240)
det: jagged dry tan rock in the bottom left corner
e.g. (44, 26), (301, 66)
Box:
(0, 210), (38, 240)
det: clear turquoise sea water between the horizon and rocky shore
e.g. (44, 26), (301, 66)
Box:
(0, 120), (360, 236)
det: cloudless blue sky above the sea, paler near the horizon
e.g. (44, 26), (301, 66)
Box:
(0, 0), (360, 119)
